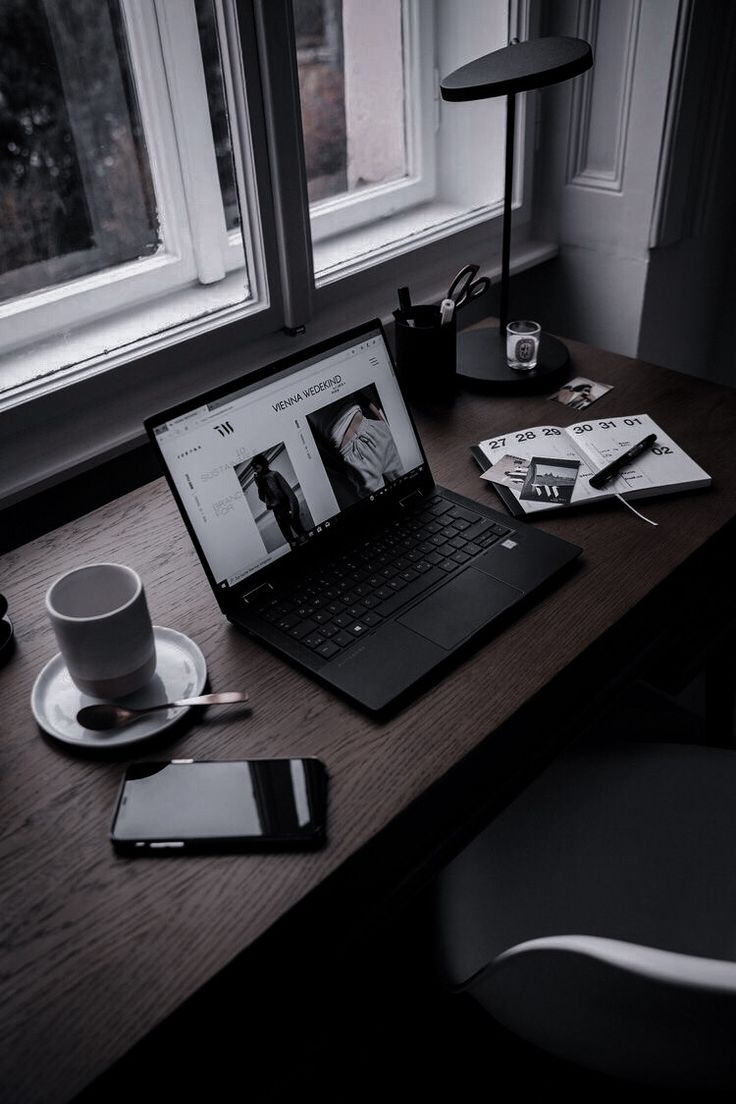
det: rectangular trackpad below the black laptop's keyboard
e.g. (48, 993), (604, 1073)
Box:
(397, 567), (524, 650)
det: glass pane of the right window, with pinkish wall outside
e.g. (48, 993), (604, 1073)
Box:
(294, 0), (408, 203)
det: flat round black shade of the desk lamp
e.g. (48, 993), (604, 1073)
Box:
(439, 38), (593, 100)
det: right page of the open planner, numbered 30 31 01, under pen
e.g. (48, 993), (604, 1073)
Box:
(567, 414), (711, 498)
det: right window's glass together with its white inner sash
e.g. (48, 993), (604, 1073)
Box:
(294, 0), (435, 241)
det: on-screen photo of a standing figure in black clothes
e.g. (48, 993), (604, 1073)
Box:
(235, 442), (314, 552)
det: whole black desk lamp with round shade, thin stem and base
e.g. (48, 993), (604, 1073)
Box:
(440, 38), (593, 391)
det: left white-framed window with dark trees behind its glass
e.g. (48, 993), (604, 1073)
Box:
(0, 0), (262, 386)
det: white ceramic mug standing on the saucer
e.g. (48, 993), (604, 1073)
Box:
(46, 563), (156, 698)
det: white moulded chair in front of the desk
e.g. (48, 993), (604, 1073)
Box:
(433, 743), (736, 1089)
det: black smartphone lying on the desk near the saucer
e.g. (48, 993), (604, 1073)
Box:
(110, 757), (328, 854)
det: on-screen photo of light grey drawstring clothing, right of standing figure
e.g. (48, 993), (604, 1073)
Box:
(307, 383), (404, 510)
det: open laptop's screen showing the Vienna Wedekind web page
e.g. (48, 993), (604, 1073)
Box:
(151, 328), (424, 586)
